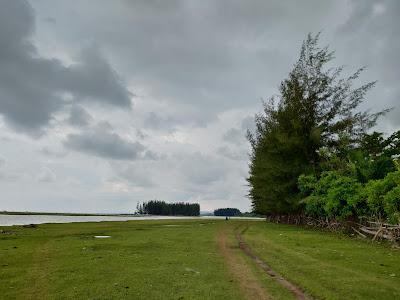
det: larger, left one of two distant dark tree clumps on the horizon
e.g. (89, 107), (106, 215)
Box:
(136, 200), (200, 216)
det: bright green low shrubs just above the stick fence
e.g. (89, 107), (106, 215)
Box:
(298, 170), (400, 223)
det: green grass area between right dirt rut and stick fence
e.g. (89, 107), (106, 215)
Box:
(244, 222), (400, 299)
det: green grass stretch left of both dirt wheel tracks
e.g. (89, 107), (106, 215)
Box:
(0, 220), (242, 299)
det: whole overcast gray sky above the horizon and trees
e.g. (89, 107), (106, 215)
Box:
(0, 0), (400, 212)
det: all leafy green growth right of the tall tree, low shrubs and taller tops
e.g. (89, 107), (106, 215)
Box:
(298, 131), (400, 223)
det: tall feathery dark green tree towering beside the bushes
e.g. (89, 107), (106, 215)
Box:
(248, 34), (385, 214)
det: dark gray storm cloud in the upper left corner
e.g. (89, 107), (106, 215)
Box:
(0, 0), (132, 136)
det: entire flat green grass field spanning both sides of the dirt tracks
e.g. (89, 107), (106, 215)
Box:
(0, 219), (400, 299)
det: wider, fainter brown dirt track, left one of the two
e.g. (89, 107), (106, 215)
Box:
(217, 227), (272, 300)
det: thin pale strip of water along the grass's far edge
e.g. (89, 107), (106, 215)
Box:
(0, 214), (263, 226)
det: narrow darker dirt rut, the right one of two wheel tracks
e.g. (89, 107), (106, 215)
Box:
(235, 227), (312, 300)
